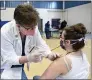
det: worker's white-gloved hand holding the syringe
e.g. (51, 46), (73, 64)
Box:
(27, 47), (44, 63)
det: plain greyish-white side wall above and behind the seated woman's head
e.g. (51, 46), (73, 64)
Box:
(65, 3), (92, 32)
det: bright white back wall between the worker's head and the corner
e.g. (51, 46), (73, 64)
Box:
(37, 9), (62, 30)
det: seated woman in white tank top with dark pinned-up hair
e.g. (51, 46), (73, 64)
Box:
(34, 23), (90, 79)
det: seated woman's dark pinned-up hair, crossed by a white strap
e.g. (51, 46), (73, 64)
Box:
(64, 23), (87, 51)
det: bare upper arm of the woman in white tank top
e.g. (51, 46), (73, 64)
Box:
(41, 58), (66, 79)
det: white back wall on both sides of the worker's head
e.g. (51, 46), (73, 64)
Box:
(1, 8), (62, 31)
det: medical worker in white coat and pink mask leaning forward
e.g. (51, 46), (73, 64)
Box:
(1, 4), (59, 79)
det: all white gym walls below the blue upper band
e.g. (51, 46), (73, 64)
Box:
(1, 3), (92, 32)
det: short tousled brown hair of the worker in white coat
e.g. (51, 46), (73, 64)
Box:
(14, 4), (39, 26)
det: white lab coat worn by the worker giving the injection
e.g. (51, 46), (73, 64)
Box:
(1, 20), (51, 79)
